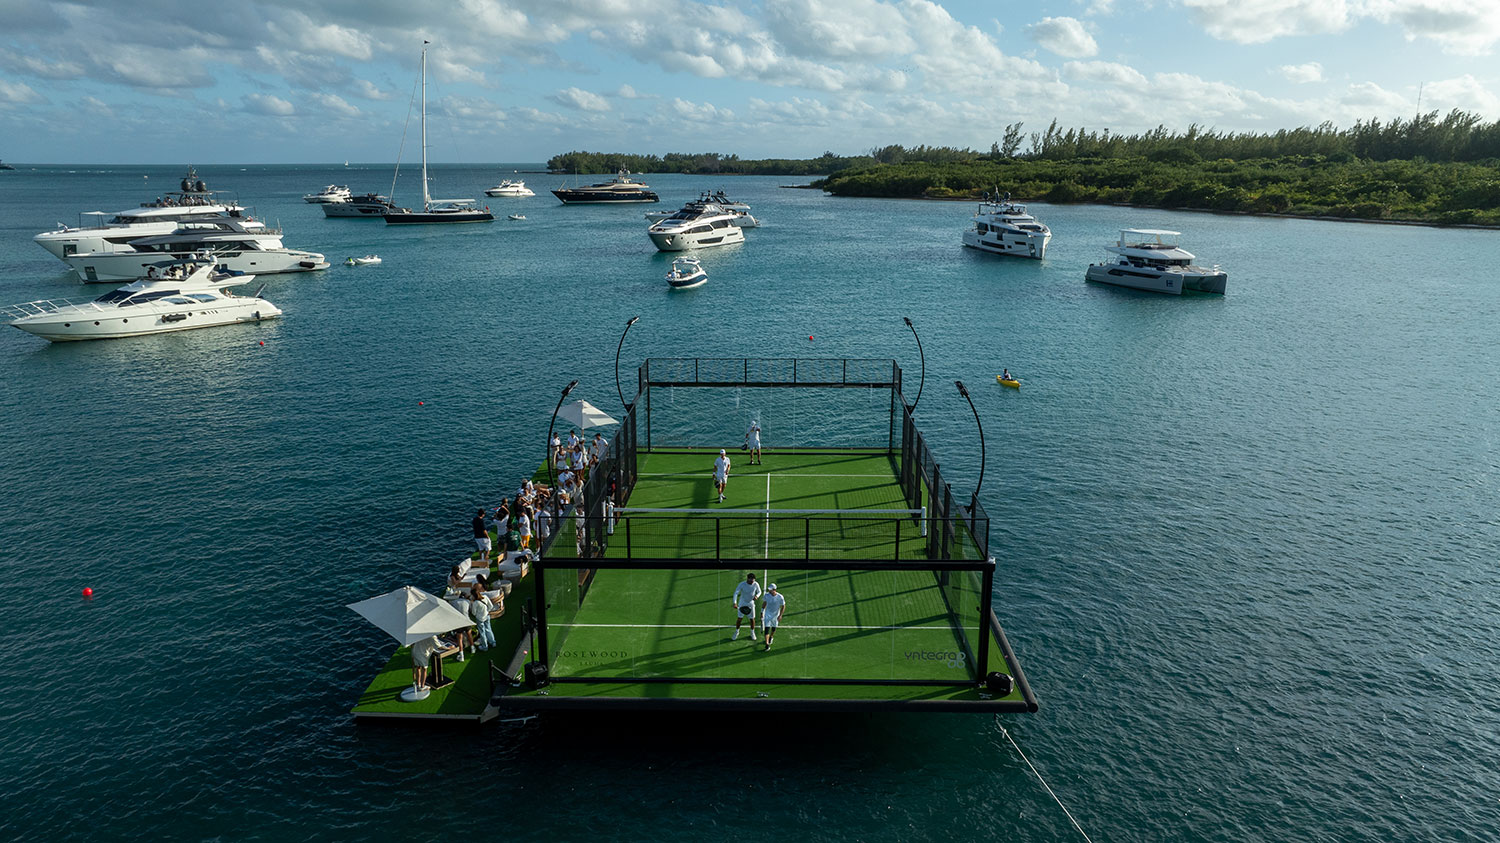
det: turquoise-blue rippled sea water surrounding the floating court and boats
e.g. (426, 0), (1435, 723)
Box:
(0, 167), (1500, 842)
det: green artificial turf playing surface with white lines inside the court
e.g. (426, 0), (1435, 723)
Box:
(548, 450), (989, 683)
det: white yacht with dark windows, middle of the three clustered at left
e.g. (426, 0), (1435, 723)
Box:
(63, 221), (329, 282)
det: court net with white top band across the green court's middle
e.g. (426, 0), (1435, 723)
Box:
(611, 507), (929, 560)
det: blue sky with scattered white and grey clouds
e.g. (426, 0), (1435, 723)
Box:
(0, 0), (1500, 164)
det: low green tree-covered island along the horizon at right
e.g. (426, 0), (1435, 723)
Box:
(548, 110), (1500, 227)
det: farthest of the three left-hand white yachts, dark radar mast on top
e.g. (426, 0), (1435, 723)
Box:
(33, 167), (261, 258)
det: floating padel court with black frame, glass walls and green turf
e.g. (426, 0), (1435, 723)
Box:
(492, 359), (1037, 714)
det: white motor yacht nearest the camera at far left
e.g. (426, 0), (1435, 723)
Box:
(0, 261), (282, 342)
